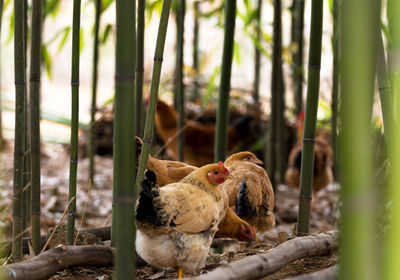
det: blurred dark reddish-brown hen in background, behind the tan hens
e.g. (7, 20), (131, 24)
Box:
(155, 100), (251, 166)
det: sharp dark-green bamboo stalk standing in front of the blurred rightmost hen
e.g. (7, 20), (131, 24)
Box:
(297, 0), (323, 235)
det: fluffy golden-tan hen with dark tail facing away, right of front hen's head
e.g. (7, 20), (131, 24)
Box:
(221, 151), (275, 232)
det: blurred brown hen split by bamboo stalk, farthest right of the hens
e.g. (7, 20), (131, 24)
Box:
(285, 112), (333, 196)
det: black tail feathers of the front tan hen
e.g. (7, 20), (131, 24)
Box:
(136, 170), (162, 226)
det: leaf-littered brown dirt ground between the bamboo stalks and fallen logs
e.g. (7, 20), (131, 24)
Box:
(0, 132), (339, 280)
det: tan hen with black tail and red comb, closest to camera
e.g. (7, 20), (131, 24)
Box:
(136, 162), (229, 278)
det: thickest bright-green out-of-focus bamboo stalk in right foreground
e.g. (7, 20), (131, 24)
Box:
(339, 0), (380, 280)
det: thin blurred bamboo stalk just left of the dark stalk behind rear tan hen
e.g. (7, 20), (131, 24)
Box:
(253, 0), (262, 116)
